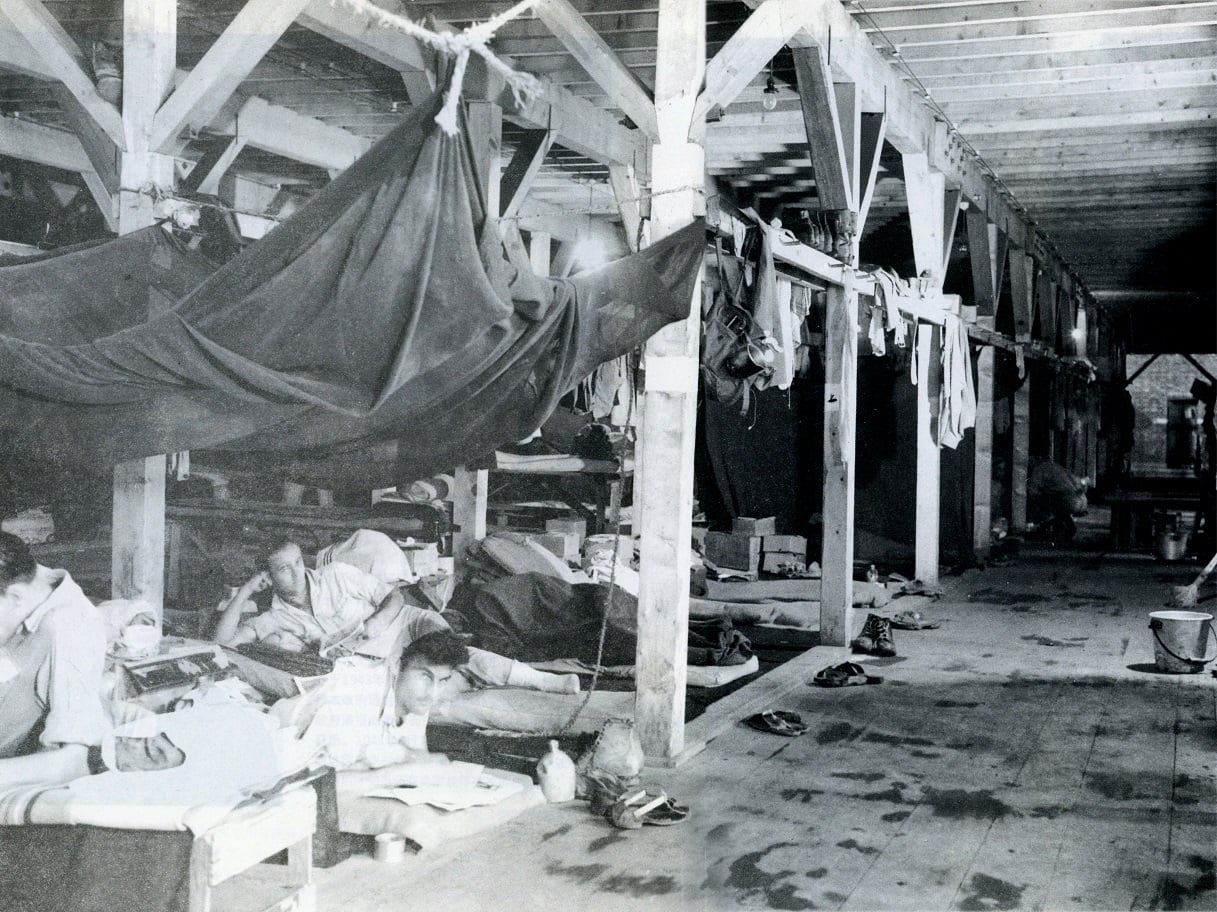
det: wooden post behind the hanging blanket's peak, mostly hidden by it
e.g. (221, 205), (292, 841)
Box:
(453, 101), (501, 567)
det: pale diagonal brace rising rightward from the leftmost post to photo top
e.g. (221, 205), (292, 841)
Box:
(150, 0), (312, 152)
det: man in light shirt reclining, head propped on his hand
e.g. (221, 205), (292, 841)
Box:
(215, 542), (579, 694)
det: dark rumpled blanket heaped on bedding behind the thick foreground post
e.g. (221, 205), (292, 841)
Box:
(444, 574), (752, 665)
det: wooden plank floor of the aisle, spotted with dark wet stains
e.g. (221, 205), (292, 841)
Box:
(230, 552), (1217, 912)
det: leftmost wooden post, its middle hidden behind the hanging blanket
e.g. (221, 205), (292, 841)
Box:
(111, 0), (176, 611)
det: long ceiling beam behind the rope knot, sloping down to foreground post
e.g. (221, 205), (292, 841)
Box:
(299, 0), (650, 174)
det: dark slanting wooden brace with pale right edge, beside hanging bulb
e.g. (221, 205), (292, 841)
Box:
(791, 47), (854, 209)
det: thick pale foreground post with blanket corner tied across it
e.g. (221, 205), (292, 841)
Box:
(634, 0), (706, 759)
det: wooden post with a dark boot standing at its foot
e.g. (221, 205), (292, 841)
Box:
(820, 275), (858, 647)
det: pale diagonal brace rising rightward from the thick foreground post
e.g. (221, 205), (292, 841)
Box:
(697, 0), (807, 114)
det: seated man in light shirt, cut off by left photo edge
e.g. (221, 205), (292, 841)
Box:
(0, 532), (184, 791)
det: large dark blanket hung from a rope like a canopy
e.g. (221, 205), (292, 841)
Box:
(0, 93), (705, 485)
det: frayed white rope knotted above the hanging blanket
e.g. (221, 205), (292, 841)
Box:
(330, 0), (542, 136)
